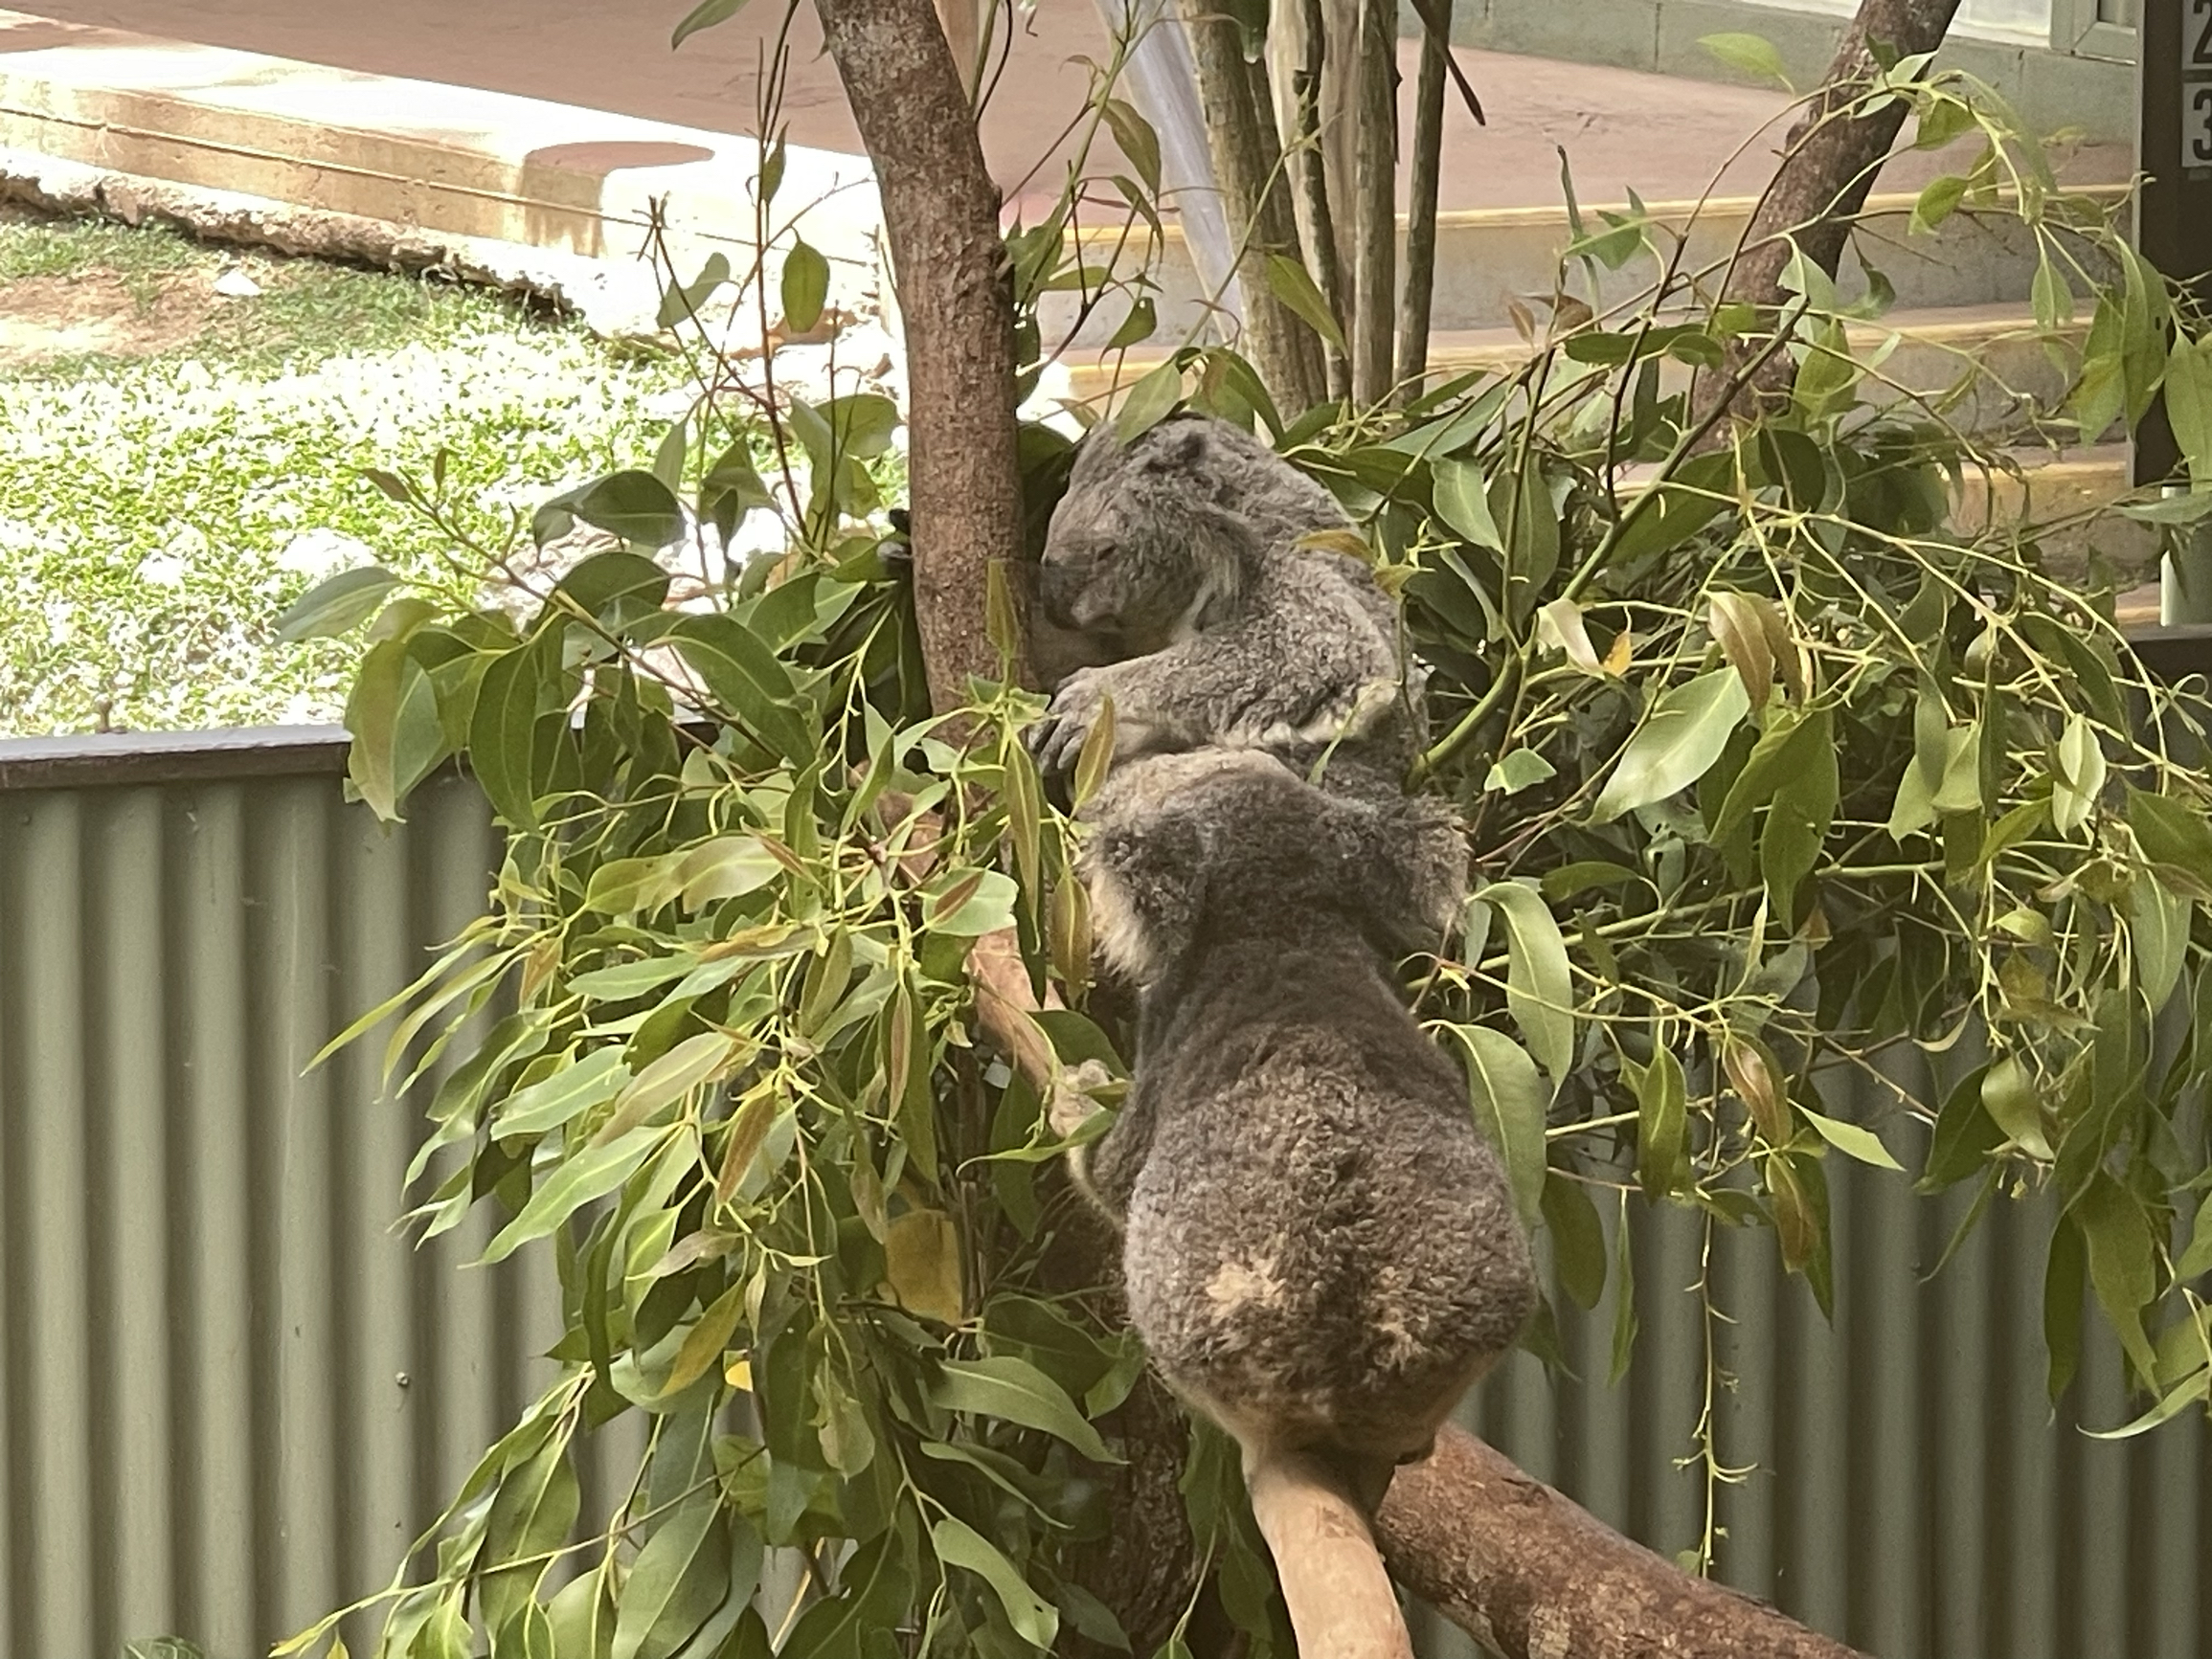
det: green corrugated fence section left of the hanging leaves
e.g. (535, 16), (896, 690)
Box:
(0, 732), (654, 1659)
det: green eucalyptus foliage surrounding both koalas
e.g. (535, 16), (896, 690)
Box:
(290, 35), (2212, 1659)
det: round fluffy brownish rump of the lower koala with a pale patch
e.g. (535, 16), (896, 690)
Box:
(1123, 1031), (1533, 1458)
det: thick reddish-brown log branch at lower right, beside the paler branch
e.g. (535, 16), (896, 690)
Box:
(1376, 1426), (1854, 1659)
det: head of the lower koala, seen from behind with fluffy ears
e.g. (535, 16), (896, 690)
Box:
(1082, 750), (1467, 984)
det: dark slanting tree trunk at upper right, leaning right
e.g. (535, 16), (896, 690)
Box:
(1694, 0), (1957, 436)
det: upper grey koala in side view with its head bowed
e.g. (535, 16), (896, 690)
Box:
(1028, 415), (1427, 795)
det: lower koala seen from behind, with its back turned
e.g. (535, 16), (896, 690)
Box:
(1084, 750), (1535, 1504)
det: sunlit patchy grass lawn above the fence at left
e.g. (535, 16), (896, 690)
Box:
(0, 214), (686, 736)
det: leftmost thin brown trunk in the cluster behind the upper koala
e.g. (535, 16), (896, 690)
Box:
(1177, 0), (1327, 414)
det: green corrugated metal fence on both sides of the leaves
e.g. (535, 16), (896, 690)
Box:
(0, 732), (2212, 1659)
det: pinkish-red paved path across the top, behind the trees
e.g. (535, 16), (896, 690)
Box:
(0, 0), (2128, 224)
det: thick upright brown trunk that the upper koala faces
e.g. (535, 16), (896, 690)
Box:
(816, 0), (1028, 710)
